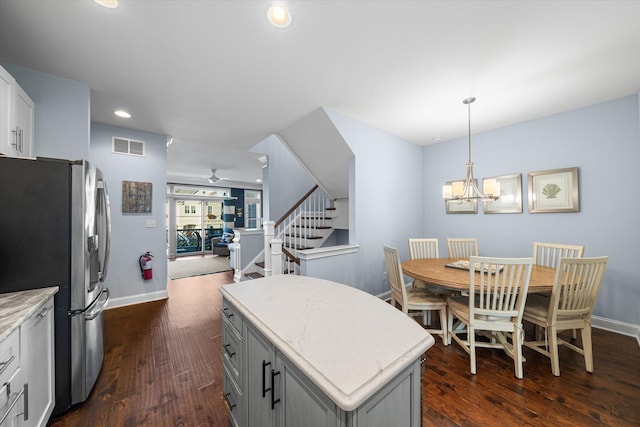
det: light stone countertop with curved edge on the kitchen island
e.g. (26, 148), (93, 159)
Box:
(220, 275), (435, 411)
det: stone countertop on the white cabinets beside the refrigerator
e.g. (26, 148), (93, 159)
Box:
(0, 286), (58, 341)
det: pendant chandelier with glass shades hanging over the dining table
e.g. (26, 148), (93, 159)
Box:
(442, 97), (500, 203)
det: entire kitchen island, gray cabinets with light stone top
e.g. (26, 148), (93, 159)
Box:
(220, 275), (434, 427)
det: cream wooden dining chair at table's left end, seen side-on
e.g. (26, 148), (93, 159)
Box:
(383, 245), (449, 345)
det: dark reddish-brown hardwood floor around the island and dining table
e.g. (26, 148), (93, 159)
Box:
(49, 272), (640, 427)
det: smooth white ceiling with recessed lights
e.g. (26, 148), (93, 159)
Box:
(0, 0), (640, 186)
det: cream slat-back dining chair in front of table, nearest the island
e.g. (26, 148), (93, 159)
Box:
(447, 256), (533, 378)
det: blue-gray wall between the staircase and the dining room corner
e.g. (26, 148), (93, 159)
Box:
(327, 110), (424, 295)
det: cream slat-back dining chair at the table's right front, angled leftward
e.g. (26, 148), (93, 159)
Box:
(522, 256), (608, 376)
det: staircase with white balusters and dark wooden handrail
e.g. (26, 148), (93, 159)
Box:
(243, 185), (336, 279)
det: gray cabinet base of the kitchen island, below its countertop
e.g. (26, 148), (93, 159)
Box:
(223, 301), (421, 427)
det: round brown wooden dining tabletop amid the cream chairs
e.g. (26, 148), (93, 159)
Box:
(402, 258), (556, 293)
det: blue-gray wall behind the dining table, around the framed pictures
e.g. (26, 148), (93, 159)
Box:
(422, 95), (640, 325)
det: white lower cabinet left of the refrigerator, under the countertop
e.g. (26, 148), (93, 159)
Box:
(0, 297), (55, 427)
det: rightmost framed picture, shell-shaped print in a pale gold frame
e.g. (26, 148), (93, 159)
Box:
(528, 167), (580, 213)
